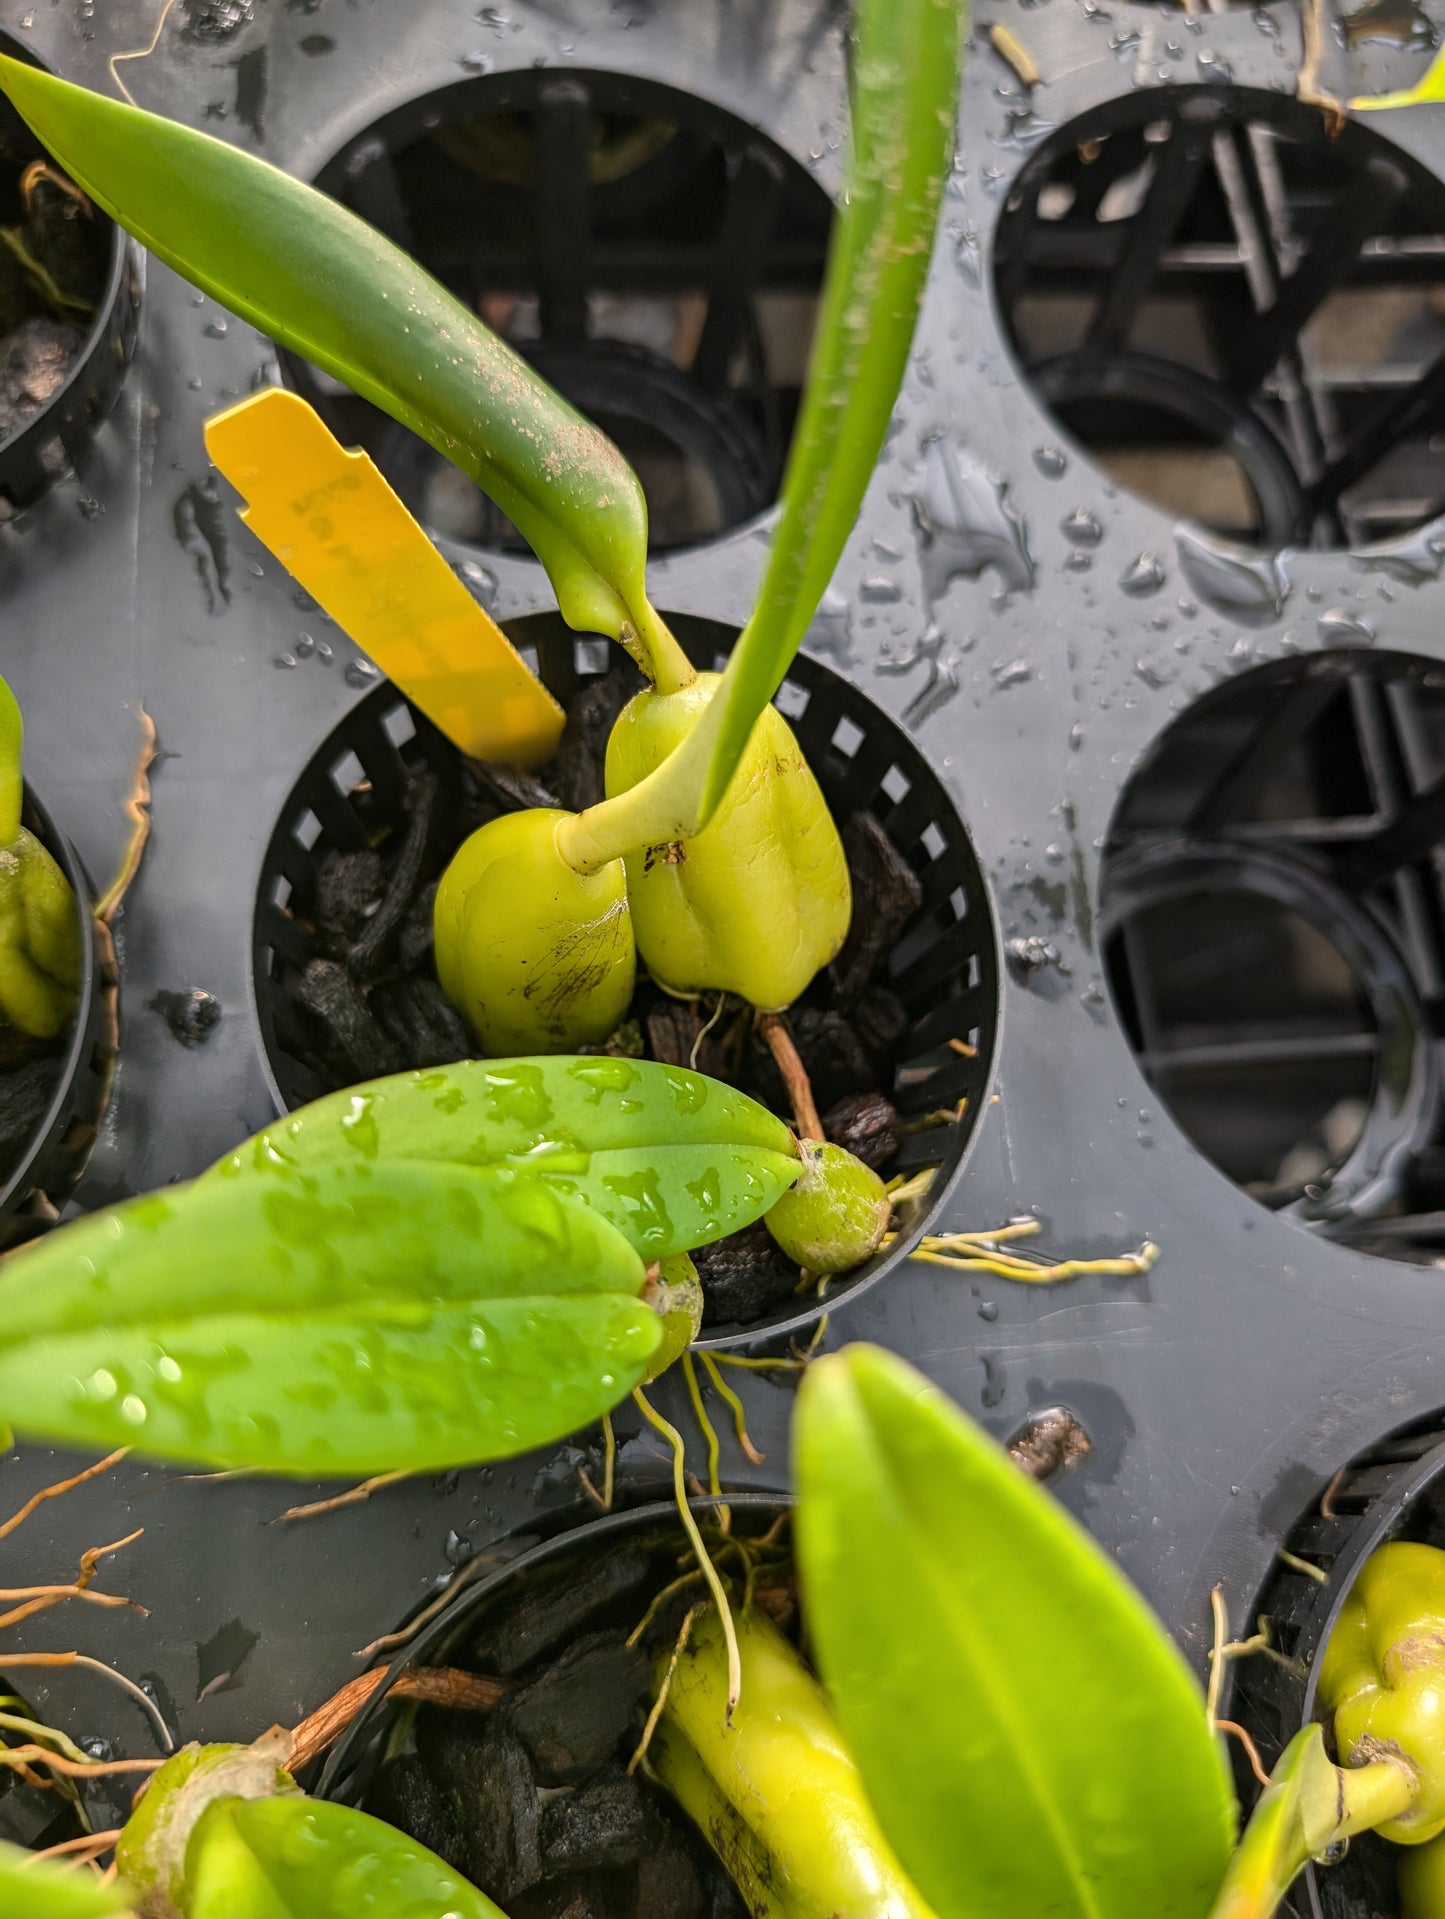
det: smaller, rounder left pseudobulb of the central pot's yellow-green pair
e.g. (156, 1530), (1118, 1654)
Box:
(434, 808), (637, 1055)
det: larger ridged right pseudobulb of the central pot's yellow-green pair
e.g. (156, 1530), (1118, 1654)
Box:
(606, 674), (852, 1011)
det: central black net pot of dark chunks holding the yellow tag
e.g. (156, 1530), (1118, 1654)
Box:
(253, 616), (998, 1345)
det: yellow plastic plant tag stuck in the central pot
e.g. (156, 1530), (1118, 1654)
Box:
(205, 388), (564, 766)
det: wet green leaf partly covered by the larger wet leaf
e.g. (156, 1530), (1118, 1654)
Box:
(207, 1057), (800, 1261)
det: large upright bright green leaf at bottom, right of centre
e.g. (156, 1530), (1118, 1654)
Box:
(794, 1345), (1232, 1919)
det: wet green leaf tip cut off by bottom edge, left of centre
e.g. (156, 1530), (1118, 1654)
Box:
(186, 1798), (507, 1919)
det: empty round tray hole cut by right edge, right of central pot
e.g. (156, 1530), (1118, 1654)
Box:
(1102, 649), (1445, 1261)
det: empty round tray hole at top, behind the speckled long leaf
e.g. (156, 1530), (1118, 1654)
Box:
(282, 67), (833, 553)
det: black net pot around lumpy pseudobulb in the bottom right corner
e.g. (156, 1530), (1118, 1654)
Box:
(1222, 1418), (1445, 1919)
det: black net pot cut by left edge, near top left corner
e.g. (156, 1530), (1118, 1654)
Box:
(0, 33), (140, 522)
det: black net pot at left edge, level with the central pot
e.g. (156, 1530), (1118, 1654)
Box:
(0, 787), (115, 1249)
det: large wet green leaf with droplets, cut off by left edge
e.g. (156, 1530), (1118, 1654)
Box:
(0, 1161), (660, 1474)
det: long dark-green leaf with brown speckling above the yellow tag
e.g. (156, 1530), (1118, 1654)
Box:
(0, 58), (656, 643)
